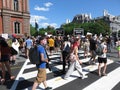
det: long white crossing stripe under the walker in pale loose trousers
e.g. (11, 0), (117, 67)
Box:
(25, 60), (113, 90)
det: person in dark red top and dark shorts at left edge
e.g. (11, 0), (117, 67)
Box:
(0, 39), (15, 84)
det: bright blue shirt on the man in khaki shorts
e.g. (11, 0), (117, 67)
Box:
(36, 45), (47, 68)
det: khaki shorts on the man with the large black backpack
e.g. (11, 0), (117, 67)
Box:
(35, 68), (46, 83)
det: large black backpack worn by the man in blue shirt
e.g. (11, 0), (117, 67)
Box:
(29, 45), (40, 64)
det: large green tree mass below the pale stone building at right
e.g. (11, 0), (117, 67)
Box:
(61, 20), (110, 35)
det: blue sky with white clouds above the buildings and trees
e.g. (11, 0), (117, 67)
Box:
(29, 0), (120, 28)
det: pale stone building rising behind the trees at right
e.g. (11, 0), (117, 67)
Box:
(72, 10), (120, 36)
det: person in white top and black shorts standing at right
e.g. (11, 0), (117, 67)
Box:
(98, 41), (107, 76)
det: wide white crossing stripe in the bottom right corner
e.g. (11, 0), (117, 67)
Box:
(83, 67), (120, 90)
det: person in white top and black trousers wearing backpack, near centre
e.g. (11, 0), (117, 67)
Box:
(61, 37), (71, 74)
